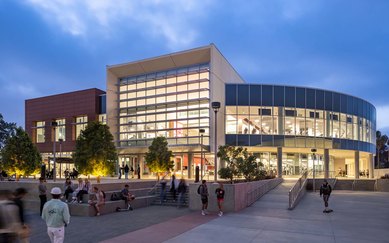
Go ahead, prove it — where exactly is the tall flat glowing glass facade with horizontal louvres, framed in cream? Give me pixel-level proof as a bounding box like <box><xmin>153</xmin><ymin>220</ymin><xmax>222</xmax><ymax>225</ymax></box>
<box><xmin>118</xmin><ymin>64</ymin><xmax>210</xmax><ymax>147</ymax></box>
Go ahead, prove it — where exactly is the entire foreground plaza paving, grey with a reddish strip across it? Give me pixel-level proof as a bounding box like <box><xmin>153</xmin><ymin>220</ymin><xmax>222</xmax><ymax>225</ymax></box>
<box><xmin>29</xmin><ymin>182</ymin><xmax>389</xmax><ymax>243</ymax></box>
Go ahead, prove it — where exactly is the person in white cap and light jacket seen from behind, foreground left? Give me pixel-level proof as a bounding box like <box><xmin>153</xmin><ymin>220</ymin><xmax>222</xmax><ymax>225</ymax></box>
<box><xmin>42</xmin><ymin>187</ymin><xmax>70</xmax><ymax>243</ymax></box>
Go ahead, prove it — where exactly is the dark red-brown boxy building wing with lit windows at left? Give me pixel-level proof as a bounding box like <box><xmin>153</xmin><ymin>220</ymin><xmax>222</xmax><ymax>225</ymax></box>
<box><xmin>25</xmin><ymin>89</ymin><xmax>106</xmax><ymax>178</ymax></box>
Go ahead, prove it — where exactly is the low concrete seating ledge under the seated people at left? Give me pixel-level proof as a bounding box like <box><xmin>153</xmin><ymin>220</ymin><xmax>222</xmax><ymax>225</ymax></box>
<box><xmin>68</xmin><ymin>195</ymin><xmax>156</xmax><ymax>216</ymax></box>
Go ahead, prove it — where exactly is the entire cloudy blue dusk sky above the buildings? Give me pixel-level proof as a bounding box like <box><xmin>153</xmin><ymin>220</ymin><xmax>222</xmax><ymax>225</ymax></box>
<box><xmin>0</xmin><ymin>0</ymin><xmax>389</xmax><ymax>134</ymax></box>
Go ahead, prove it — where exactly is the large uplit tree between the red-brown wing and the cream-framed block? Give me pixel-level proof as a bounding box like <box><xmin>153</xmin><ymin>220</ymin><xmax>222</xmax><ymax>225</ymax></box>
<box><xmin>73</xmin><ymin>121</ymin><xmax>117</xmax><ymax>178</ymax></box>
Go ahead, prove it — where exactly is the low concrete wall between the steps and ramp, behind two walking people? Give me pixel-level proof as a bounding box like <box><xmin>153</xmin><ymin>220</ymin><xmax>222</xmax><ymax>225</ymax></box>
<box><xmin>189</xmin><ymin>178</ymin><xmax>282</xmax><ymax>212</ymax></box>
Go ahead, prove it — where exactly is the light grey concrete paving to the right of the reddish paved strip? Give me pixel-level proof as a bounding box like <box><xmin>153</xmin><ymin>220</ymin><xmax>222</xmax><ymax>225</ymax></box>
<box><xmin>166</xmin><ymin>189</ymin><xmax>389</xmax><ymax>243</ymax></box>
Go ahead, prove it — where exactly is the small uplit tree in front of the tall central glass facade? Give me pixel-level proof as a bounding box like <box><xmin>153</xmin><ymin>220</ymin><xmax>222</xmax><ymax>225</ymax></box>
<box><xmin>146</xmin><ymin>137</ymin><xmax>174</xmax><ymax>180</ymax></box>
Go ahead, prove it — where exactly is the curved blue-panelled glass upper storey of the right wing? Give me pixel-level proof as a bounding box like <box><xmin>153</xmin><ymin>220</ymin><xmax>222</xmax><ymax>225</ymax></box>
<box><xmin>225</xmin><ymin>84</ymin><xmax>376</xmax><ymax>153</ymax></box>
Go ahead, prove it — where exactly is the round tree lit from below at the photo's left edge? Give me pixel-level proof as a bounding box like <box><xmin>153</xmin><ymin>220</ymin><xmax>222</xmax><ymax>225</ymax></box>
<box><xmin>1</xmin><ymin>127</ymin><xmax>42</xmax><ymax>180</ymax></box>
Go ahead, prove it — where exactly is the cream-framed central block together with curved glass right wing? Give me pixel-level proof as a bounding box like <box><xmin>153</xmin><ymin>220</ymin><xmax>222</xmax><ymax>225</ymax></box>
<box><xmin>106</xmin><ymin>44</ymin><xmax>376</xmax><ymax>178</ymax></box>
